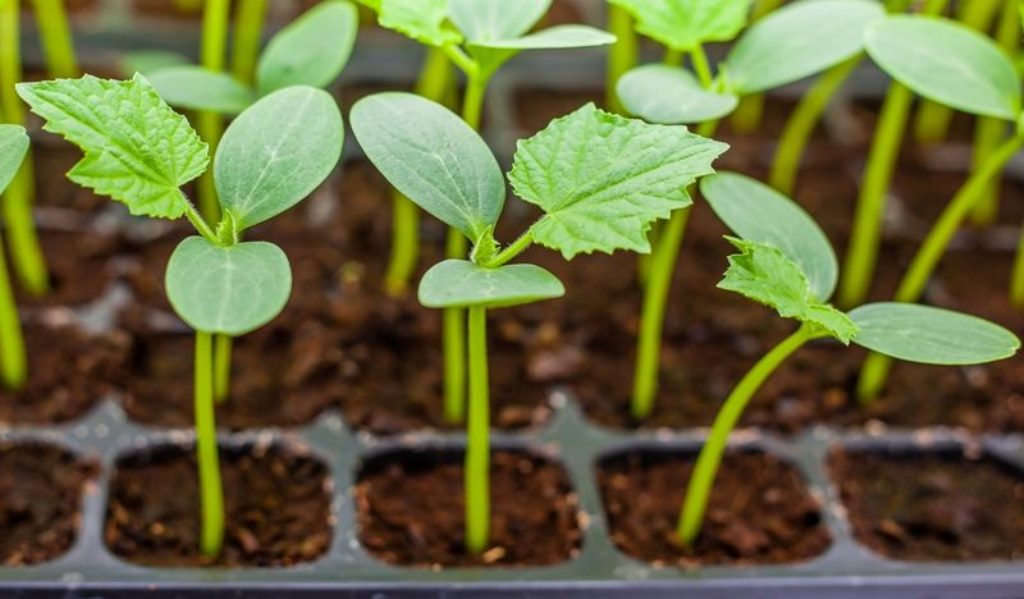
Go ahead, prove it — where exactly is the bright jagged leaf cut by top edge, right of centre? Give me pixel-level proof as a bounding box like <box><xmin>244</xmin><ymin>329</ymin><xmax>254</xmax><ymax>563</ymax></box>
<box><xmin>609</xmin><ymin>0</ymin><xmax>753</xmax><ymax>52</ymax></box>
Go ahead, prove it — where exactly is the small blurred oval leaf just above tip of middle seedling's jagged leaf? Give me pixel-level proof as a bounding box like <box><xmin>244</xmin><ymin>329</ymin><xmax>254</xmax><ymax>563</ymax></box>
<box><xmin>615</xmin><ymin>65</ymin><xmax>739</xmax><ymax>125</ymax></box>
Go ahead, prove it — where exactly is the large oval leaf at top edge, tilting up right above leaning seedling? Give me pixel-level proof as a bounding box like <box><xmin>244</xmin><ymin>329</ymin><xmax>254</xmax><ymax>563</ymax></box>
<box><xmin>725</xmin><ymin>0</ymin><xmax>886</xmax><ymax>95</ymax></box>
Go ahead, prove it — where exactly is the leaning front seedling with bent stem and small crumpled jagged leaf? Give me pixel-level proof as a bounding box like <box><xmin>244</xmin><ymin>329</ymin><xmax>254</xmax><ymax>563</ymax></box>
<box><xmin>678</xmin><ymin>173</ymin><xmax>1020</xmax><ymax>545</ymax></box>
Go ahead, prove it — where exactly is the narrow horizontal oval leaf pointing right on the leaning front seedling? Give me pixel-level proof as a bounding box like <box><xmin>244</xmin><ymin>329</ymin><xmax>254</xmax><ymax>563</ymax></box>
<box><xmin>850</xmin><ymin>303</ymin><xmax>1020</xmax><ymax>365</ymax></box>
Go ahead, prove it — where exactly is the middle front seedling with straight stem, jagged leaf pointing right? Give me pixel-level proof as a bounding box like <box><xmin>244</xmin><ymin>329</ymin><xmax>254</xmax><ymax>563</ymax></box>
<box><xmin>351</xmin><ymin>93</ymin><xmax>727</xmax><ymax>553</ymax></box>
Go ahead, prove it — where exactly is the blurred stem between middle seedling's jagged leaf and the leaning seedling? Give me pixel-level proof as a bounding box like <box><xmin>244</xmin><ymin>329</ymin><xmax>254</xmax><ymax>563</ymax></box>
<box><xmin>630</xmin><ymin>208</ymin><xmax>690</xmax><ymax>420</ymax></box>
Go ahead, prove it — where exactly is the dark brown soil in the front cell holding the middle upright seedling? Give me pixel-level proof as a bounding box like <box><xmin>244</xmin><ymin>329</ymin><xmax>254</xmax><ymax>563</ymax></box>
<box><xmin>355</xmin><ymin>452</ymin><xmax>583</xmax><ymax>567</ymax></box>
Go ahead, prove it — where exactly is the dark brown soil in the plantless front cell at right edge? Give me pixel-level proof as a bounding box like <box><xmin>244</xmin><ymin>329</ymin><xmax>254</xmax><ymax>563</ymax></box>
<box><xmin>830</xmin><ymin>452</ymin><xmax>1024</xmax><ymax>561</ymax></box>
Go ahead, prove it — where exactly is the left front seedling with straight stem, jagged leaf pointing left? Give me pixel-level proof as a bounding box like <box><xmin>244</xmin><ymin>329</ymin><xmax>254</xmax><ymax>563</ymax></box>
<box><xmin>17</xmin><ymin>75</ymin><xmax>344</xmax><ymax>556</ymax></box>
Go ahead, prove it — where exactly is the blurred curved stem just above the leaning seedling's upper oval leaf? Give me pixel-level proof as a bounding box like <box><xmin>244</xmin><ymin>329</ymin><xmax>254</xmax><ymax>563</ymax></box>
<box><xmin>769</xmin><ymin>54</ymin><xmax>863</xmax><ymax>196</ymax></box>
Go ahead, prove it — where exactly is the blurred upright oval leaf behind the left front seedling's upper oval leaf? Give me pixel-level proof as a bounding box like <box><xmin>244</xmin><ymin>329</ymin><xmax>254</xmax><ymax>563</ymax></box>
<box><xmin>256</xmin><ymin>0</ymin><xmax>359</xmax><ymax>95</ymax></box>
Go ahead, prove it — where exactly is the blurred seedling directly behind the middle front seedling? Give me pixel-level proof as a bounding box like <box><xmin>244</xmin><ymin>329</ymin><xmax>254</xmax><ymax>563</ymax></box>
<box><xmin>360</xmin><ymin>0</ymin><xmax>615</xmax><ymax>422</ymax></box>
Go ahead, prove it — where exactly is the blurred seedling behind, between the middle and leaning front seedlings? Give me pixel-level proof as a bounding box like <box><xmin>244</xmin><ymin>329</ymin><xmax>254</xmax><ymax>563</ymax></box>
<box><xmin>618</xmin><ymin>0</ymin><xmax>884</xmax><ymax>419</ymax></box>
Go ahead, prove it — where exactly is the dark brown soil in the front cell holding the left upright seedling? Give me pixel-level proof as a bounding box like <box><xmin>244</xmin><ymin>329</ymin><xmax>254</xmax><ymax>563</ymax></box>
<box><xmin>104</xmin><ymin>446</ymin><xmax>333</xmax><ymax>567</ymax></box>
